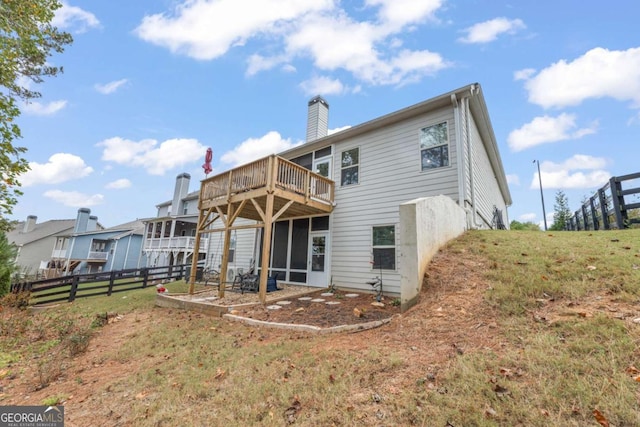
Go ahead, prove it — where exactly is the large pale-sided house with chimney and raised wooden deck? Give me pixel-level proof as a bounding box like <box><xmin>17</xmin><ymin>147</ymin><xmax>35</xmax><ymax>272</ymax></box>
<box><xmin>182</xmin><ymin>84</ymin><xmax>511</xmax><ymax>304</ymax></box>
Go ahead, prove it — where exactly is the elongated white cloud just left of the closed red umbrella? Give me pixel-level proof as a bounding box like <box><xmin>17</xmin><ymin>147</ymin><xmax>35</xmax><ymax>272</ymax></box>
<box><xmin>96</xmin><ymin>137</ymin><xmax>207</xmax><ymax>175</ymax></box>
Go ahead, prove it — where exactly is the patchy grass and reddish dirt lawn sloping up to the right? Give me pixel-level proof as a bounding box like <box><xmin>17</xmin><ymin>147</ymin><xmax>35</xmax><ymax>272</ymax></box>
<box><xmin>0</xmin><ymin>230</ymin><xmax>640</xmax><ymax>427</ymax></box>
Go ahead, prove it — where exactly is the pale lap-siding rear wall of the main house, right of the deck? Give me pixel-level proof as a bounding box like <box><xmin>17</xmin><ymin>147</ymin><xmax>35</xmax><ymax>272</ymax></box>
<box><xmin>331</xmin><ymin>108</ymin><xmax>458</xmax><ymax>294</ymax></box>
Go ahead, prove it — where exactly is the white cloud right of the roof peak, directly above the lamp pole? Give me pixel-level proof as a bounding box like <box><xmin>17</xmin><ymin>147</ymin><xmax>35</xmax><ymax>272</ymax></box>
<box><xmin>507</xmin><ymin>113</ymin><xmax>598</xmax><ymax>151</ymax></box>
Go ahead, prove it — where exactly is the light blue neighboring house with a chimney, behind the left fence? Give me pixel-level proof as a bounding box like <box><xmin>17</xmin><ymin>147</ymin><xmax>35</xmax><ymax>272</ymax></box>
<box><xmin>49</xmin><ymin>209</ymin><xmax>146</xmax><ymax>277</ymax></box>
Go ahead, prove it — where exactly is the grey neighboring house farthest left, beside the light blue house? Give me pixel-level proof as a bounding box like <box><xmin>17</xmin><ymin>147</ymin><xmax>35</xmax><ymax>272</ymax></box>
<box><xmin>7</xmin><ymin>215</ymin><xmax>76</xmax><ymax>276</ymax></box>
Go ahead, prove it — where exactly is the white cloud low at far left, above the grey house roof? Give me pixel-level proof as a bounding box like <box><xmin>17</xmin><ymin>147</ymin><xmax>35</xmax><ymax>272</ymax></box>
<box><xmin>20</xmin><ymin>153</ymin><xmax>93</xmax><ymax>187</ymax></box>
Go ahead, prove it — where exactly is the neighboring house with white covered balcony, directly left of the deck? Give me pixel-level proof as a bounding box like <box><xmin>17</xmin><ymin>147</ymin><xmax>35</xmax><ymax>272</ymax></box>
<box><xmin>142</xmin><ymin>173</ymin><xmax>255</xmax><ymax>281</ymax></box>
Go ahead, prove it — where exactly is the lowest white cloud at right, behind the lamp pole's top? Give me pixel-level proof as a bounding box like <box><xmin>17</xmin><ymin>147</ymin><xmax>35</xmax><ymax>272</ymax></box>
<box><xmin>529</xmin><ymin>154</ymin><xmax>611</xmax><ymax>189</ymax></box>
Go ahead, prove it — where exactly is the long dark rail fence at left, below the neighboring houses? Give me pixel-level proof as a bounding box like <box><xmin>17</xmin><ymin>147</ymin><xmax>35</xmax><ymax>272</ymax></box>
<box><xmin>11</xmin><ymin>264</ymin><xmax>198</xmax><ymax>305</ymax></box>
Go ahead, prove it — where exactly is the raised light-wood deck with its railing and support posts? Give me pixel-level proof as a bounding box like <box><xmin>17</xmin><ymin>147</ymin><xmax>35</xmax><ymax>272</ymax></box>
<box><xmin>189</xmin><ymin>155</ymin><xmax>335</xmax><ymax>303</ymax></box>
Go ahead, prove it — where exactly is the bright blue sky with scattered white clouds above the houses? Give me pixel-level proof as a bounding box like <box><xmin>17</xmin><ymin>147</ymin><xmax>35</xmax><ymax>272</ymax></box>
<box><xmin>8</xmin><ymin>0</ymin><xmax>640</xmax><ymax>231</ymax></box>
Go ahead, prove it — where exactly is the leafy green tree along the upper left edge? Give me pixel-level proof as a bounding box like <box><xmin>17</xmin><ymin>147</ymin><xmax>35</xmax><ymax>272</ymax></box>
<box><xmin>0</xmin><ymin>0</ymin><xmax>73</xmax><ymax>231</ymax></box>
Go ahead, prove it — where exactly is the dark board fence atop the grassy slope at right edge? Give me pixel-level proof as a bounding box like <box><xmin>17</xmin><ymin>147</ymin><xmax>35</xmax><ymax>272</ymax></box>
<box><xmin>566</xmin><ymin>172</ymin><xmax>640</xmax><ymax>230</ymax></box>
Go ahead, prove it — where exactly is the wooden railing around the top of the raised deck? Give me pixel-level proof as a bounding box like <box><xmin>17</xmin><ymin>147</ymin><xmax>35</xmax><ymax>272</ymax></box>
<box><xmin>200</xmin><ymin>155</ymin><xmax>335</xmax><ymax>204</ymax></box>
